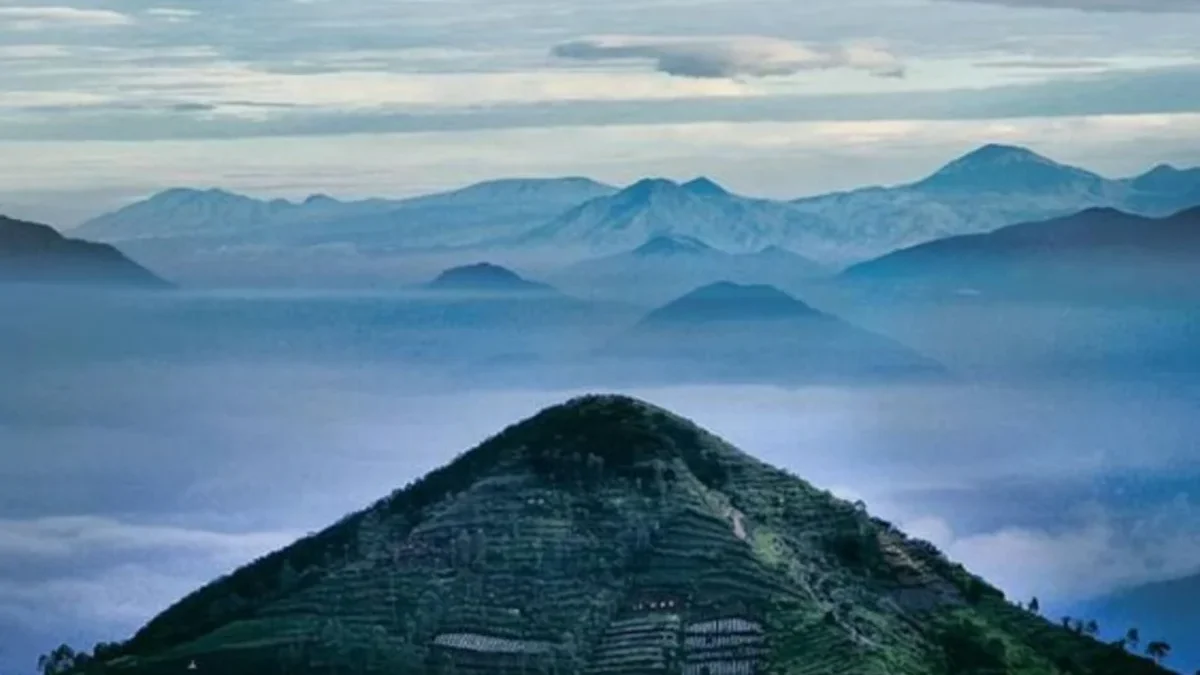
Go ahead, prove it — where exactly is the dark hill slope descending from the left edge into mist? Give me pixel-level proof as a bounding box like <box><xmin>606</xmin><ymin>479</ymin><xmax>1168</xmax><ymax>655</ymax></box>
<box><xmin>0</xmin><ymin>216</ymin><xmax>169</xmax><ymax>287</ymax></box>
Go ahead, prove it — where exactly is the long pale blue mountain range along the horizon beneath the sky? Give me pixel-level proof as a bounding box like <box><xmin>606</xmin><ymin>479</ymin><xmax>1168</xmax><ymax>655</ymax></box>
<box><xmin>77</xmin><ymin>144</ymin><xmax>1200</xmax><ymax>274</ymax></box>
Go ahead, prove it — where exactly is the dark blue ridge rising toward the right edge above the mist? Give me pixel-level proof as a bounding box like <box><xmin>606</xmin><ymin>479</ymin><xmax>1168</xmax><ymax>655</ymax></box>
<box><xmin>842</xmin><ymin>208</ymin><xmax>1200</xmax><ymax>298</ymax></box>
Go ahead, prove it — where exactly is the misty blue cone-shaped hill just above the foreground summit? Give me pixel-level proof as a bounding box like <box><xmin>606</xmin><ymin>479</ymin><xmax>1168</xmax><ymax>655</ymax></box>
<box><xmin>599</xmin><ymin>282</ymin><xmax>944</xmax><ymax>383</ymax></box>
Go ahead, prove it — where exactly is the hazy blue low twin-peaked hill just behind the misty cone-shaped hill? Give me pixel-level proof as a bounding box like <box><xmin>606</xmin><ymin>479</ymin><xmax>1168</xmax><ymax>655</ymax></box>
<box><xmin>550</xmin><ymin>234</ymin><xmax>830</xmax><ymax>304</ymax></box>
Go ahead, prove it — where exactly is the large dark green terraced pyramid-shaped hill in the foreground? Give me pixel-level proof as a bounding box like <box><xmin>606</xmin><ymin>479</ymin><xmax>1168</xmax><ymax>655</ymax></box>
<box><xmin>72</xmin><ymin>396</ymin><xmax>1165</xmax><ymax>675</ymax></box>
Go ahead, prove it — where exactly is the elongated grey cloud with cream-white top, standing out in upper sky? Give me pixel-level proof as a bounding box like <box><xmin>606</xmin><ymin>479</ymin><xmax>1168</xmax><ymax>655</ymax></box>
<box><xmin>552</xmin><ymin>35</ymin><xmax>905</xmax><ymax>78</ymax></box>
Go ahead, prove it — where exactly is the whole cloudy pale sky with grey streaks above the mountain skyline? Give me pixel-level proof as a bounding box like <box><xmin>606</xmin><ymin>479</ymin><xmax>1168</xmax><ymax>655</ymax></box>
<box><xmin>0</xmin><ymin>0</ymin><xmax>1200</xmax><ymax>221</ymax></box>
